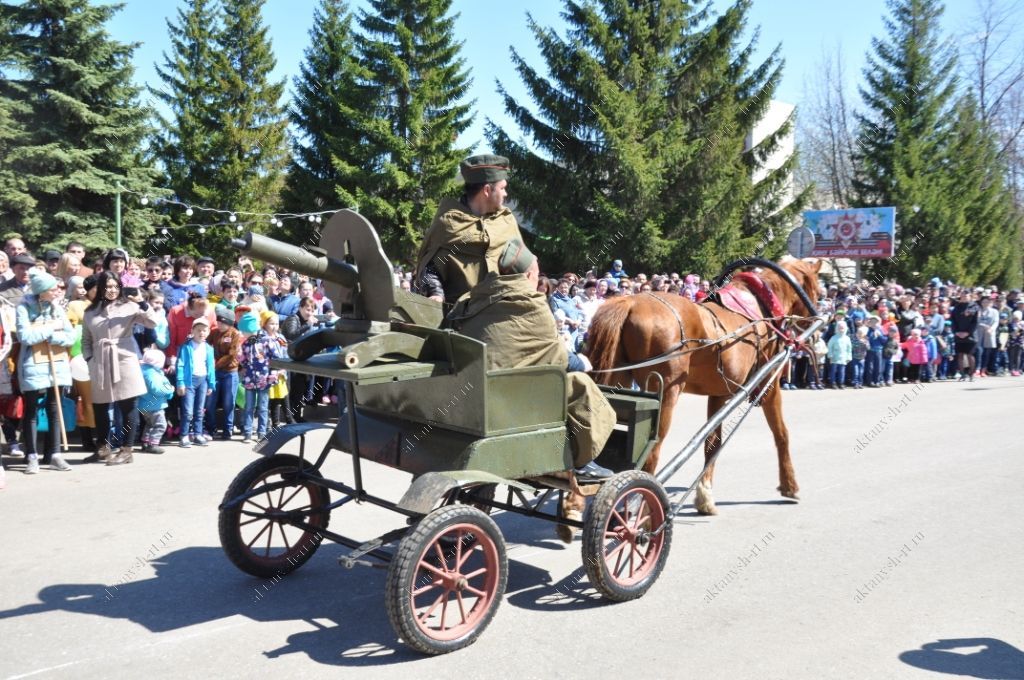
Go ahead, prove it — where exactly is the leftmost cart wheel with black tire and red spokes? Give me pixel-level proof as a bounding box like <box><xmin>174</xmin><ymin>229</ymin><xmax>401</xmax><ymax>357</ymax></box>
<box><xmin>218</xmin><ymin>454</ymin><xmax>331</xmax><ymax>578</ymax></box>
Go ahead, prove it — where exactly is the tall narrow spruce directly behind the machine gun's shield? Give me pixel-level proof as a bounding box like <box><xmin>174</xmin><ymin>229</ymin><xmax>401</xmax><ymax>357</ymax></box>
<box><xmin>353</xmin><ymin>0</ymin><xmax>472</xmax><ymax>260</ymax></box>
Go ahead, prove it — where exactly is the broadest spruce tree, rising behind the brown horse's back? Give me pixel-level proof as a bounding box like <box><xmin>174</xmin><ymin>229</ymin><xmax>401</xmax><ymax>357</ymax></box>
<box><xmin>487</xmin><ymin>0</ymin><xmax>799</xmax><ymax>273</ymax></box>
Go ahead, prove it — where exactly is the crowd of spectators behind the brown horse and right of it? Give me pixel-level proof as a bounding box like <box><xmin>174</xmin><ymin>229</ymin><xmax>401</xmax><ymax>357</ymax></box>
<box><xmin>538</xmin><ymin>260</ymin><xmax>1024</xmax><ymax>390</ymax></box>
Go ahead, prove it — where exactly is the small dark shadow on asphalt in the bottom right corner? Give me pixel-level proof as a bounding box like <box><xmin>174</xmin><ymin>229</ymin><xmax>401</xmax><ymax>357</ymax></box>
<box><xmin>899</xmin><ymin>638</ymin><xmax>1024</xmax><ymax>680</ymax></box>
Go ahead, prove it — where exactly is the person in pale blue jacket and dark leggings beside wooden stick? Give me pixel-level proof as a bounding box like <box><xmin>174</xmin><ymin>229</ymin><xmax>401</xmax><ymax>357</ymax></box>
<box><xmin>16</xmin><ymin>271</ymin><xmax>75</xmax><ymax>474</ymax></box>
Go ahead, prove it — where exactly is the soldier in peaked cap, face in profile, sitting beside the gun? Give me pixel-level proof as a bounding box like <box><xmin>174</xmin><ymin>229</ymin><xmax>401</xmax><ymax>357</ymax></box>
<box><xmin>415</xmin><ymin>155</ymin><xmax>522</xmax><ymax>304</ymax></box>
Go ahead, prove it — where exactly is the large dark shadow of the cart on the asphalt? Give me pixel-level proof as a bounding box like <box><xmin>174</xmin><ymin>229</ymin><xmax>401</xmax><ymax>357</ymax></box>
<box><xmin>0</xmin><ymin>522</ymin><xmax>565</xmax><ymax>667</ymax></box>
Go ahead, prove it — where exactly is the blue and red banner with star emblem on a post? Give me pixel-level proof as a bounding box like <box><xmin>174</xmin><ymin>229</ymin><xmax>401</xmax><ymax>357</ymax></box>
<box><xmin>804</xmin><ymin>208</ymin><xmax>896</xmax><ymax>259</ymax></box>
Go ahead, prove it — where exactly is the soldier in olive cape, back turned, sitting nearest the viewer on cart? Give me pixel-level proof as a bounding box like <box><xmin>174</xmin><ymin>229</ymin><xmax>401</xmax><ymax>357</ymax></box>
<box><xmin>445</xmin><ymin>239</ymin><xmax>615</xmax><ymax>481</ymax></box>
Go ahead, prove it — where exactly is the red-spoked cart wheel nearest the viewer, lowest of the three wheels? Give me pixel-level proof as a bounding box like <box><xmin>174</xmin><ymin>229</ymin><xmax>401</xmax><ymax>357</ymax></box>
<box><xmin>385</xmin><ymin>505</ymin><xmax>508</xmax><ymax>654</ymax></box>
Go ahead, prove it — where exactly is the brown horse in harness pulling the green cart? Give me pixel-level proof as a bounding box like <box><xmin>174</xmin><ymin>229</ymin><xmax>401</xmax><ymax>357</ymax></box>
<box><xmin>581</xmin><ymin>258</ymin><xmax>821</xmax><ymax>515</ymax></box>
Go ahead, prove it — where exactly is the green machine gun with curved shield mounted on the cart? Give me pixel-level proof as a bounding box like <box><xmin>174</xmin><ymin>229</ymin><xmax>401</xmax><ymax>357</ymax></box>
<box><xmin>231</xmin><ymin>210</ymin><xmax>442</xmax><ymax>369</ymax></box>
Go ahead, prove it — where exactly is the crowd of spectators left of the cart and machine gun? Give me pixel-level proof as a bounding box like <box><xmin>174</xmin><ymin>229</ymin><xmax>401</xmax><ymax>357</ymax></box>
<box><xmin>0</xmin><ymin>238</ymin><xmax>338</xmax><ymax>483</ymax></box>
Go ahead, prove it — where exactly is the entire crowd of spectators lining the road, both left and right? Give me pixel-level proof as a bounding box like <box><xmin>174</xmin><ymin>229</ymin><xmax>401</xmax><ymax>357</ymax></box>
<box><xmin>0</xmin><ymin>238</ymin><xmax>1024</xmax><ymax>483</ymax></box>
